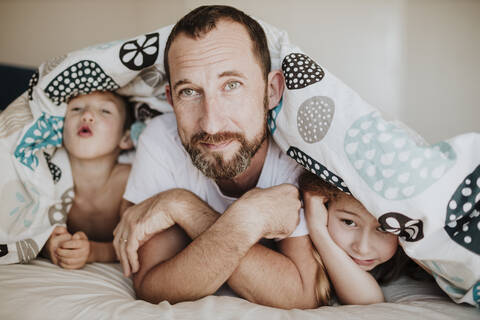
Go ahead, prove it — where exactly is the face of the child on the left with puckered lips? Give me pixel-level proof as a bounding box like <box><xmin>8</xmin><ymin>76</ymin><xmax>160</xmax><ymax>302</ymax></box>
<box><xmin>63</xmin><ymin>92</ymin><xmax>126</xmax><ymax>159</ymax></box>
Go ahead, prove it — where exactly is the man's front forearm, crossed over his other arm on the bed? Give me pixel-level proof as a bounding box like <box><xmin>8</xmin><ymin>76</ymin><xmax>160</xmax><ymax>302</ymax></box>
<box><xmin>137</xmin><ymin>212</ymin><xmax>255</xmax><ymax>303</ymax></box>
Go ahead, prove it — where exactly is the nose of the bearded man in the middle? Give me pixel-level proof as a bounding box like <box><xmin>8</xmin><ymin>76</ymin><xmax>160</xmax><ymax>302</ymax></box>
<box><xmin>199</xmin><ymin>95</ymin><xmax>227</xmax><ymax>134</ymax></box>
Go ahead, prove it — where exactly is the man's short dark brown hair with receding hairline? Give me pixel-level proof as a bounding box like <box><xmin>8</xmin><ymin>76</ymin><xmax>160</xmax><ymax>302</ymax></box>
<box><xmin>163</xmin><ymin>5</ymin><xmax>271</xmax><ymax>82</ymax></box>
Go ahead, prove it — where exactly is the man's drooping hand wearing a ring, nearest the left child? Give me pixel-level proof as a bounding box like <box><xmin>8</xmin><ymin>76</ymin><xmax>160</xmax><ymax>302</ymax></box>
<box><xmin>113</xmin><ymin>192</ymin><xmax>175</xmax><ymax>277</ymax></box>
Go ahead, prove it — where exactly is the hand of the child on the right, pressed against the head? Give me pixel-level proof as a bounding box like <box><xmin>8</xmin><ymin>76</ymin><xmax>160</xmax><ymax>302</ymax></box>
<box><xmin>303</xmin><ymin>191</ymin><xmax>328</xmax><ymax>232</ymax></box>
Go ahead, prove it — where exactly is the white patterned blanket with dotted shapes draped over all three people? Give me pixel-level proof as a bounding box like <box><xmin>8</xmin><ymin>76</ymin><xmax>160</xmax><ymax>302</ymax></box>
<box><xmin>0</xmin><ymin>18</ymin><xmax>480</xmax><ymax>306</ymax></box>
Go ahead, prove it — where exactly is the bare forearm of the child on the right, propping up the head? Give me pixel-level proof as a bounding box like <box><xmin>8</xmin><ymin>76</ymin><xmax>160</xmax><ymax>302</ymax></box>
<box><xmin>310</xmin><ymin>229</ymin><xmax>385</xmax><ymax>304</ymax></box>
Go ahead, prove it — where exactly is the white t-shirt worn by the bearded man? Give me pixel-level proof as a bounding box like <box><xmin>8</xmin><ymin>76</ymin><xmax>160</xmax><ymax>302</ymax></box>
<box><xmin>124</xmin><ymin>113</ymin><xmax>308</xmax><ymax>237</ymax></box>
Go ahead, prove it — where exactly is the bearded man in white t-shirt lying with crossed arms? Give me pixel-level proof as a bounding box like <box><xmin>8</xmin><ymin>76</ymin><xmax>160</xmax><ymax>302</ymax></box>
<box><xmin>114</xmin><ymin>6</ymin><xmax>318</xmax><ymax>308</ymax></box>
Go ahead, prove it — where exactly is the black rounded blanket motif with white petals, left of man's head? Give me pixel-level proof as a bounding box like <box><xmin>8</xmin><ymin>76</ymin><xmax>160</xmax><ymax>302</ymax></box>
<box><xmin>119</xmin><ymin>33</ymin><xmax>160</xmax><ymax>70</ymax></box>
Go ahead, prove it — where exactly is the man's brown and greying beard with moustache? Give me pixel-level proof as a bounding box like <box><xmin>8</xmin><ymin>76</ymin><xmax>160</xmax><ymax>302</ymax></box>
<box><xmin>182</xmin><ymin>94</ymin><xmax>268</xmax><ymax>180</ymax></box>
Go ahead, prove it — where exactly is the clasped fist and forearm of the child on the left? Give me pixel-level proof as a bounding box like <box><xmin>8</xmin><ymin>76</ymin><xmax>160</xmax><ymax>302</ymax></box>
<box><xmin>56</xmin><ymin>231</ymin><xmax>117</xmax><ymax>269</ymax></box>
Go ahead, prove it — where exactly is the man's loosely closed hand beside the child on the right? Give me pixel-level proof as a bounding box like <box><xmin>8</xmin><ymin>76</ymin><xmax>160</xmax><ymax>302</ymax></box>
<box><xmin>228</xmin><ymin>184</ymin><xmax>301</xmax><ymax>239</ymax></box>
